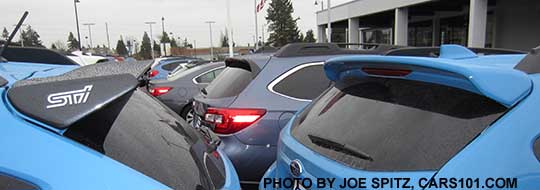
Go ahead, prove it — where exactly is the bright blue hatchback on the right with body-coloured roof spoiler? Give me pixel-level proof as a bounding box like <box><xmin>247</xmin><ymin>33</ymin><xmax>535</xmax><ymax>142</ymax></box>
<box><xmin>259</xmin><ymin>45</ymin><xmax>540</xmax><ymax>189</ymax></box>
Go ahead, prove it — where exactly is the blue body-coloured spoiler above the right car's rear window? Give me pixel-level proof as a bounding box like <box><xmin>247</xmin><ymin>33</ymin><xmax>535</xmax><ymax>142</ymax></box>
<box><xmin>324</xmin><ymin>54</ymin><xmax>532</xmax><ymax>107</ymax></box>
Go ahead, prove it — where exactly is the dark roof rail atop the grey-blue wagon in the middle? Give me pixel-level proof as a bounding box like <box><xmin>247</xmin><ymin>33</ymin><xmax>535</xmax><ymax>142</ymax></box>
<box><xmin>274</xmin><ymin>43</ymin><xmax>393</xmax><ymax>57</ymax></box>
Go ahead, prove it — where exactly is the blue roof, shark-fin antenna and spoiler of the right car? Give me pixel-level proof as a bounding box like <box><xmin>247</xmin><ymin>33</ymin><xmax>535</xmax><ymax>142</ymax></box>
<box><xmin>325</xmin><ymin>46</ymin><xmax>532</xmax><ymax>107</ymax></box>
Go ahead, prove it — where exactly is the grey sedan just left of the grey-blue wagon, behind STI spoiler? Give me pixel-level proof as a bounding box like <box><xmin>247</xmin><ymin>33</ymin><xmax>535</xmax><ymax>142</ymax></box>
<box><xmin>149</xmin><ymin>62</ymin><xmax>225</xmax><ymax>124</ymax></box>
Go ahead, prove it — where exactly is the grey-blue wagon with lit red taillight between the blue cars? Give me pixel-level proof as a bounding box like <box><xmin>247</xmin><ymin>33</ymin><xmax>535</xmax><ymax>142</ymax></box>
<box><xmin>194</xmin><ymin>44</ymin><xmax>394</xmax><ymax>185</ymax></box>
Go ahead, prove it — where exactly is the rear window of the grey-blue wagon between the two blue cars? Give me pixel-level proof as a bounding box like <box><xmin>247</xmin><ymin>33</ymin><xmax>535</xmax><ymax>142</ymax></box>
<box><xmin>205</xmin><ymin>67</ymin><xmax>253</xmax><ymax>98</ymax></box>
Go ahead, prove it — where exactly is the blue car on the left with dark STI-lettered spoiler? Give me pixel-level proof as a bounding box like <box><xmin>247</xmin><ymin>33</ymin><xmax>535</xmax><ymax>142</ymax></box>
<box><xmin>0</xmin><ymin>58</ymin><xmax>240</xmax><ymax>190</ymax></box>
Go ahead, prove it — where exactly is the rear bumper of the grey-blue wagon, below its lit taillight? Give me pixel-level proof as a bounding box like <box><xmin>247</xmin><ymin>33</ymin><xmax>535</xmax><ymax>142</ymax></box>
<box><xmin>220</xmin><ymin>136</ymin><xmax>276</xmax><ymax>183</ymax></box>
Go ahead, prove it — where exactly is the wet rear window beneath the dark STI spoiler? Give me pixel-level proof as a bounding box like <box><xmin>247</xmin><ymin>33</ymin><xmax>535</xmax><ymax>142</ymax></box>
<box><xmin>64</xmin><ymin>90</ymin><xmax>225</xmax><ymax>189</ymax></box>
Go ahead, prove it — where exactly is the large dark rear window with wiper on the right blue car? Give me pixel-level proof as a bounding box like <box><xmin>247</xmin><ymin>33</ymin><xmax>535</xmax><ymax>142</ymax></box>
<box><xmin>292</xmin><ymin>78</ymin><xmax>507</xmax><ymax>171</ymax></box>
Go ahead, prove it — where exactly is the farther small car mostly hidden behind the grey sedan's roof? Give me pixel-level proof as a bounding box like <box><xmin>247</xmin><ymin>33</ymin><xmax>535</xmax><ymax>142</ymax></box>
<box><xmin>151</xmin><ymin>57</ymin><xmax>201</xmax><ymax>80</ymax></box>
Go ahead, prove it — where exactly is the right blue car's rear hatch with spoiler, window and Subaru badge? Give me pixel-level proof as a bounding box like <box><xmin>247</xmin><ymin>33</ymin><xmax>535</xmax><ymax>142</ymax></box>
<box><xmin>276</xmin><ymin>56</ymin><xmax>532</xmax><ymax>187</ymax></box>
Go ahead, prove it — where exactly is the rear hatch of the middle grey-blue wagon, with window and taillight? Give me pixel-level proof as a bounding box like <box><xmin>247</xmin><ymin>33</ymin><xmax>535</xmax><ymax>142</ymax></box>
<box><xmin>193</xmin><ymin>58</ymin><xmax>267</xmax><ymax>133</ymax></box>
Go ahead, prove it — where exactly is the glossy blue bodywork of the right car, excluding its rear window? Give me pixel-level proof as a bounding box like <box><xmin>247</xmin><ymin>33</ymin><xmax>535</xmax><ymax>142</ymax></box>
<box><xmin>259</xmin><ymin>50</ymin><xmax>540</xmax><ymax>189</ymax></box>
